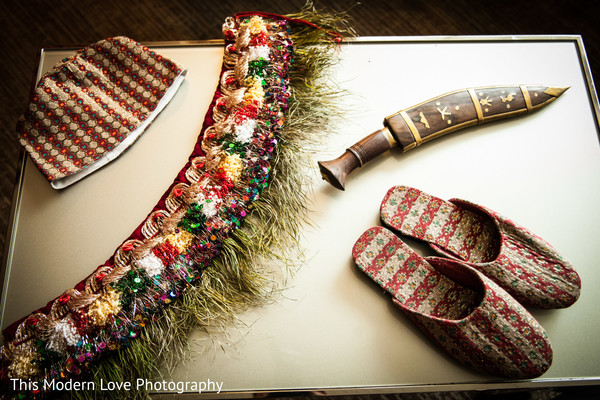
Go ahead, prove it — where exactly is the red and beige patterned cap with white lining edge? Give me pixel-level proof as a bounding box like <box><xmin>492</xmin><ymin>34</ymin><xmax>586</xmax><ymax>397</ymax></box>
<box><xmin>17</xmin><ymin>36</ymin><xmax>186</xmax><ymax>189</ymax></box>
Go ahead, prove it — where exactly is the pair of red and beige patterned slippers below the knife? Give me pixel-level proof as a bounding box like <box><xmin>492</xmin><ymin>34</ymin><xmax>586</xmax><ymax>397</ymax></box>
<box><xmin>352</xmin><ymin>186</ymin><xmax>581</xmax><ymax>379</ymax></box>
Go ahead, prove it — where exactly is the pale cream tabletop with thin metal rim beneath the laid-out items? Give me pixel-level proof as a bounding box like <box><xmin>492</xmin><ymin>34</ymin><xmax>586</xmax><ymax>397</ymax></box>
<box><xmin>2</xmin><ymin>36</ymin><xmax>600</xmax><ymax>397</ymax></box>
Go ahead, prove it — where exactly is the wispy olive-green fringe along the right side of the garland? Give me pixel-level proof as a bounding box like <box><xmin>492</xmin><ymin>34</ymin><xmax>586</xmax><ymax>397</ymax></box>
<box><xmin>61</xmin><ymin>2</ymin><xmax>354</xmax><ymax>400</ymax></box>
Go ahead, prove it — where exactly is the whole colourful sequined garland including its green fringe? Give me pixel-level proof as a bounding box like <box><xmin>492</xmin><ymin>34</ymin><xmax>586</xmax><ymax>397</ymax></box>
<box><xmin>0</xmin><ymin>5</ymin><xmax>352</xmax><ymax>398</ymax></box>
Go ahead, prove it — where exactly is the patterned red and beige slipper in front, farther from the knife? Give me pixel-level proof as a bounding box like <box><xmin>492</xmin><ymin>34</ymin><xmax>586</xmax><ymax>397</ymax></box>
<box><xmin>352</xmin><ymin>227</ymin><xmax>552</xmax><ymax>379</ymax></box>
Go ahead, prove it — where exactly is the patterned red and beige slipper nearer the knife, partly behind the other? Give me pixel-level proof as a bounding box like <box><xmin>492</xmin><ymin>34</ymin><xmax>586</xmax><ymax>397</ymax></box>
<box><xmin>381</xmin><ymin>186</ymin><xmax>581</xmax><ymax>308</ymax></box>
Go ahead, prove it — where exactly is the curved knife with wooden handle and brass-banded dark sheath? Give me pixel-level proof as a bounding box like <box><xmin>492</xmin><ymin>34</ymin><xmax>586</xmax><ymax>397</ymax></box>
<box><xmin>318</xmin><ymin>85</ymin><xmax>568</xmax><ymax>190</ymax></box>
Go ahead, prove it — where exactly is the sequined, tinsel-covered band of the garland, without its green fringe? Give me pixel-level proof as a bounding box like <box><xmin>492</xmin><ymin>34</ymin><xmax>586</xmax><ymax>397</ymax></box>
<box><xmin>1</xmin><ymin>15</ymin><xmax>293</xmax><ymax>390</ymax></box>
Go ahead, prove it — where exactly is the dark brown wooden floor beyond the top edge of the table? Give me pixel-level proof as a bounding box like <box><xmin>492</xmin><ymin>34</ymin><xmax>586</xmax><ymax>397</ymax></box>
<box><xmin>0</xmin><ymin>0</ymin><xmax>600</xmax><ymax>398</ymax></box>
